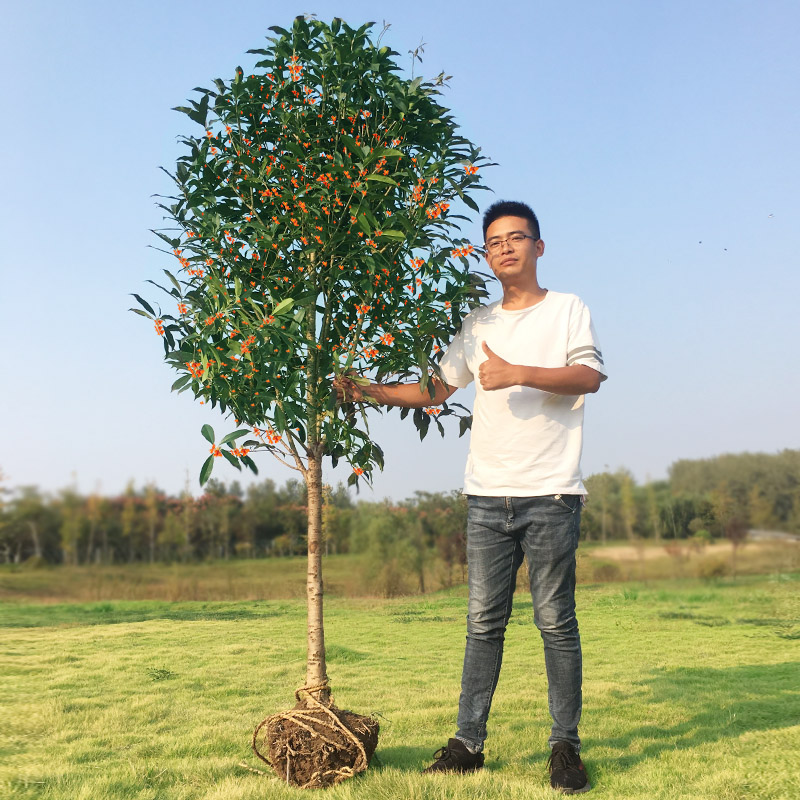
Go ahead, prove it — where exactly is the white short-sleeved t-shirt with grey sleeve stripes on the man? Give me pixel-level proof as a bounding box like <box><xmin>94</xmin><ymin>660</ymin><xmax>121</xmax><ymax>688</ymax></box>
<box><xmin>439</xmin><ymin>291</ymin><xmax>607</xmax><ymax>497</ymax></box>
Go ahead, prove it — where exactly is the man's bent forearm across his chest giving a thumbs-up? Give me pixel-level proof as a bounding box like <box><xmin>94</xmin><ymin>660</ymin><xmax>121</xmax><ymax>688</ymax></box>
<box><xmin>478</xmin><ymin>342</ymin><xmax>602</xmax><ymax>394</ymax></box>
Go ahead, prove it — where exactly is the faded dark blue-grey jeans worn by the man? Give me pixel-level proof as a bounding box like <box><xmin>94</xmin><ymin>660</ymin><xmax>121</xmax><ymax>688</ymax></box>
<box><xmin>456</xmin><ymin>495</ymin><xmax>582</xmax><ymax>751</ymax></box>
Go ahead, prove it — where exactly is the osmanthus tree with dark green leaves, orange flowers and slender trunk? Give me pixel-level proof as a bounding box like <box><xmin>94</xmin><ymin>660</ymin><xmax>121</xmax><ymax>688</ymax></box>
<box><xmin>136</xmin><ymin>17</ymin><xmax>488</xmax><ymax>785</ymax></box>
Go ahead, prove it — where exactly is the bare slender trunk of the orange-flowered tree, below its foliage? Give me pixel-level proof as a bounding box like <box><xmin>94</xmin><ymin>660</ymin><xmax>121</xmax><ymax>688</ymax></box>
<box><xmin>306</xmin><ymin>453</ymin><xmax>330</xmax><ymax>703</ymax></box>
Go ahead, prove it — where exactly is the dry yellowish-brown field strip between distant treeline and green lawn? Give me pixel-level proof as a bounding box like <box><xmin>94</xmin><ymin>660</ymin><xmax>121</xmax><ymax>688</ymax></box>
<box><xmin>0</xmin><ymin>541</ymin><xmax>800</xmax><ymax>603</ymax></box>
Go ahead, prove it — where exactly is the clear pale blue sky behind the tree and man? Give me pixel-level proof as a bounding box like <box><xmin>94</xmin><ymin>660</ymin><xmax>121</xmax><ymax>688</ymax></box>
<box><xmin>0</xmin><ymin>0</ymin><xmax>800</xmax><ymax>500</ymax></box>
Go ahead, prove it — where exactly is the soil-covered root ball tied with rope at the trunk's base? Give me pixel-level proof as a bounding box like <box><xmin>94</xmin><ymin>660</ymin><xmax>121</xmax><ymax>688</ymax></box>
<box><xmin>253</xmin><ymin>689</ymin><xmax>379</xmax><ymax>789</ymax></box>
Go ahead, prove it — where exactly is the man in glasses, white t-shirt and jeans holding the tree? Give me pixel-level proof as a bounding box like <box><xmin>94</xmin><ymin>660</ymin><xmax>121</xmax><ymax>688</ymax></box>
<box><xmin>340</xmin><ymin>202</ymin><xmax>606</xmax><ymax>794</ymax></box>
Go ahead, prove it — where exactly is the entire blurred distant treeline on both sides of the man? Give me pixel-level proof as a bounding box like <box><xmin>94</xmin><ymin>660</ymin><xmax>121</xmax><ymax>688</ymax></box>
<box><xmin>0</xmin><ymin>450</ymin><xmax>800</xmax><ymax>564</ymax></box>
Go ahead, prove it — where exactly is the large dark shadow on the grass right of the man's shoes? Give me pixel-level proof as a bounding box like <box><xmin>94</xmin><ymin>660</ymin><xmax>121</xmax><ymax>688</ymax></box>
<box><xmin>587</xmin><ymin>662</ymin><xmax>800</xmax><ymax>769</ymax></box>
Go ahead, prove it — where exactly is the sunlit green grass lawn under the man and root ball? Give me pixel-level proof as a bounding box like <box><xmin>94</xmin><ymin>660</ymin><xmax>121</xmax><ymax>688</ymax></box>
<box><xmin>0</xmin><ymin>573</ymin><xmax>800</xmax><ymax>800</ymax></box>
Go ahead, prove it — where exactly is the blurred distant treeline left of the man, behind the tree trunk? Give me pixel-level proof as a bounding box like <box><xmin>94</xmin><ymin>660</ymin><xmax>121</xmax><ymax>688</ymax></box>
<box><xmin>0</xmin><ymin>472</ymin><xmax>466</xmax><ymax>591</ymax></box>
